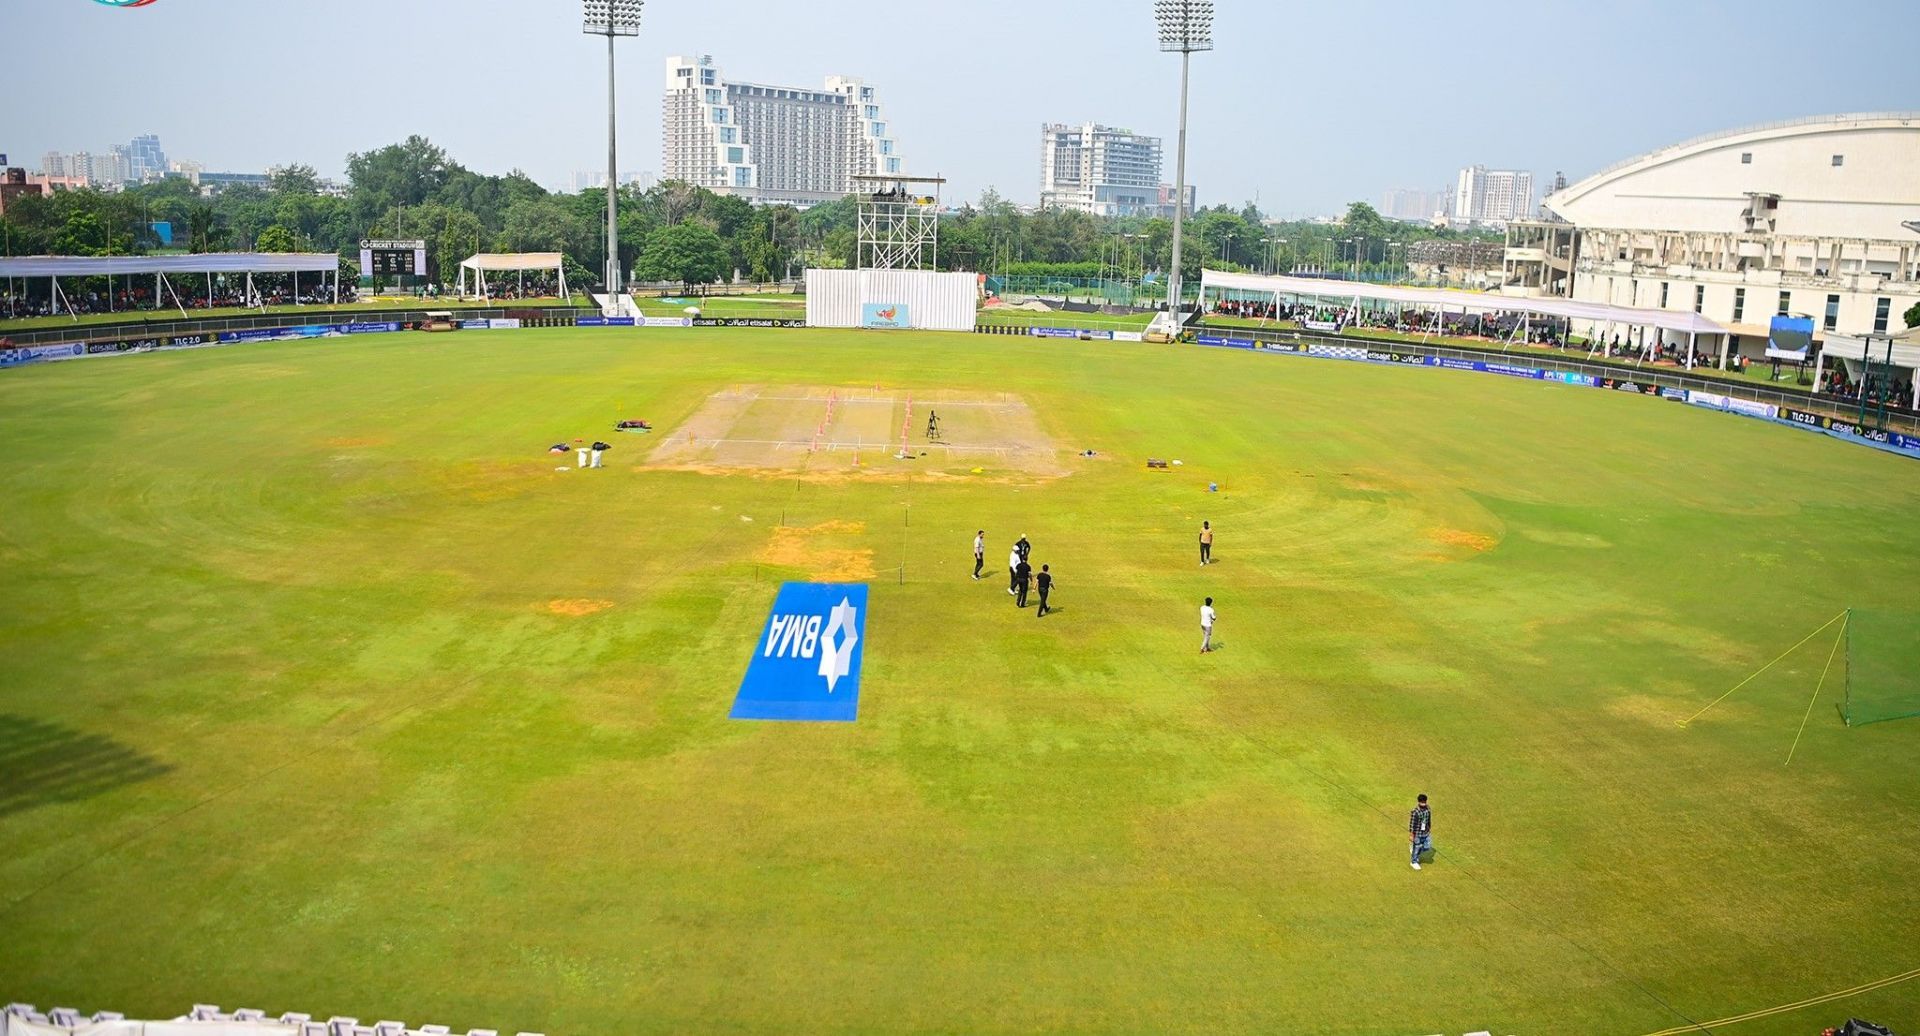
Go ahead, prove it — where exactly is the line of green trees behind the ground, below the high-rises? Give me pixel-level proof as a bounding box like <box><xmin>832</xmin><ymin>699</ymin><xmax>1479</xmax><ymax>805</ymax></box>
<box><xmin>0</xmin><ymin>136</ymin><xmax>1497</xmax><ymax>286</ymax></box>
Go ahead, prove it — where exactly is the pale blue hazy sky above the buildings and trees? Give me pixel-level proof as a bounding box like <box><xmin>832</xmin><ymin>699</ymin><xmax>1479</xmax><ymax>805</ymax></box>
<box><xmin>0</xmin><ymin>0</ymin><xmax>1920</xmax><ymax>215</ymax></box>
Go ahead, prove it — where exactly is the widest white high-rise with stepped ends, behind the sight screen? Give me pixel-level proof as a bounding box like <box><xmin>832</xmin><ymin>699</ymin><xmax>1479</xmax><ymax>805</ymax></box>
<box><xmin>660</xmin><ymin>56</ymin><xmax>902</xmax><ymax>207</ymax></box>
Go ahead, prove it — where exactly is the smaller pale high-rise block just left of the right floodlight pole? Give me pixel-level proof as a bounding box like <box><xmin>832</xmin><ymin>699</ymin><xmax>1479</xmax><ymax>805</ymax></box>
<box><xmin>1041</xmin><ymin>123</ymin><xmax>1160</xmax><ymax>215</ymax></box>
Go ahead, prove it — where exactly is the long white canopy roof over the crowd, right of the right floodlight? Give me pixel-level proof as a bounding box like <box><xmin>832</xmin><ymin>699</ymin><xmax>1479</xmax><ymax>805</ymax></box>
<box><xmin>1200</xmin><ymin>271</ymin><xmax>1728</xmax><ymax>366</ymax></box>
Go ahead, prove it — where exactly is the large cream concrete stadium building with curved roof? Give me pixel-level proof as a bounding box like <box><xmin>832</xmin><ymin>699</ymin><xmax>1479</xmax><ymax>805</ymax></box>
<box><xmin>1501</xmin><ymin>111</ymin><xmax>1920</xmax><ymax>366</ymax></box>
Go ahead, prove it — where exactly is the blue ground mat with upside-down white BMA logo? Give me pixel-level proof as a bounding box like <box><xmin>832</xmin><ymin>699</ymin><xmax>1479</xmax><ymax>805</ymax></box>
<box><xmin>730</xmin><ymin>583</ymin><xmax>866</xmax><ymax>721</ymax></box>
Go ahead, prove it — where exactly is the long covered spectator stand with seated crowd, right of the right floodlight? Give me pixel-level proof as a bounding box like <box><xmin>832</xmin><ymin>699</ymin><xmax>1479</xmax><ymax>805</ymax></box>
<box><xmin>1200</xmin><ymin>269</ymin><xmax>1732</xmax><ymax>370</ymax></box>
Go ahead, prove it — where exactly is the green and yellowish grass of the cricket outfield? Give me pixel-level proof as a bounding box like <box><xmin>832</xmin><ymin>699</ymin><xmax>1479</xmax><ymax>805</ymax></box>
<box><xmin>0</xmin><ymin>330</ymin><xmax>1920</xmax><ymax>1036</ymax></box>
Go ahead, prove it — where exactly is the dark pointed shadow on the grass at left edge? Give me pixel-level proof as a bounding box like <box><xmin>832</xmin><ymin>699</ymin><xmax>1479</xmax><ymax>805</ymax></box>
<box><xmin>0</xmin><ymin>712</ymin><xmax>173</xmax><ymax>817</ymax></box>
